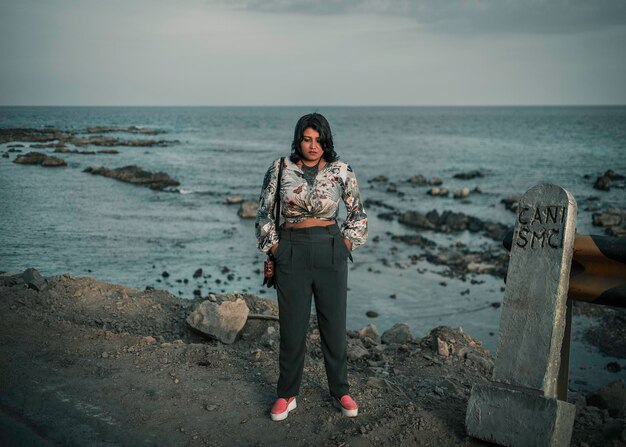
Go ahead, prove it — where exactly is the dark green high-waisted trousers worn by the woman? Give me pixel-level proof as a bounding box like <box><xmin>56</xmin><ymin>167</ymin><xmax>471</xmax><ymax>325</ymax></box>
<box><xmin>274</xmin><ymin>224</ymin><xmax>352</xmax><ymax>398</ymax></box>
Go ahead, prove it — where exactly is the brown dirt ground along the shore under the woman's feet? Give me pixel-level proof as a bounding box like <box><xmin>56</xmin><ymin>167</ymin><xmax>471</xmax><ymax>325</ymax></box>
<box><xmin>0</xmin><ymin>274</ymin><xmax>626</xmax><ymax>447</ymax></box>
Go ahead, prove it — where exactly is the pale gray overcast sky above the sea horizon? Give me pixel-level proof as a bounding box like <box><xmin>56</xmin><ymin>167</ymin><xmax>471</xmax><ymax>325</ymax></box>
<box><xmin>0</xmin><ymin>0</ymin><xmax>626</xmax><ymax>106</ymax></box>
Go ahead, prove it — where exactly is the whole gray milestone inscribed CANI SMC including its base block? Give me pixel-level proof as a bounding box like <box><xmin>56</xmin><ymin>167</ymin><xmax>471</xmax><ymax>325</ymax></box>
<box><xmin>465</xmin><ymin>185</ymin><xmax>577</xmax><ymax>447</ymax></box>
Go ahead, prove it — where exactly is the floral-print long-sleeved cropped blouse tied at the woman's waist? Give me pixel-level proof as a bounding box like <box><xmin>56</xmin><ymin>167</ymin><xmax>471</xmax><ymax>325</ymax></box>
<box><xmin>255</xmin><ymin>157</ymin><xmax>367</xmax><ymax>253</ymax></box>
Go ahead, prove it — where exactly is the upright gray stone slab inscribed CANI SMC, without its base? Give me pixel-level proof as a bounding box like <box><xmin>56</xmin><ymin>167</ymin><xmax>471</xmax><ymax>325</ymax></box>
<box><xmin>493</xmin><ymin>185</ymin><xmax>577</xmax><ymax>397</ymax></box>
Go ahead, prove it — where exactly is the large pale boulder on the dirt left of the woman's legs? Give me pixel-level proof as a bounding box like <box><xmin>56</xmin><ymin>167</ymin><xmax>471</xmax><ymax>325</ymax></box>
<box><xmin>187</xmin><ymin>298</ymin><xmax>250</xmax><ymax>344</ymax></box>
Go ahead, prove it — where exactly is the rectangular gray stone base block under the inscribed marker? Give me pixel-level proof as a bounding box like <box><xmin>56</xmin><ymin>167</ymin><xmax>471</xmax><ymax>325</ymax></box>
<box><xmin>465</xmin><ymin>384</ymin><xmax>576</xmax><ymax>447</ymax></box>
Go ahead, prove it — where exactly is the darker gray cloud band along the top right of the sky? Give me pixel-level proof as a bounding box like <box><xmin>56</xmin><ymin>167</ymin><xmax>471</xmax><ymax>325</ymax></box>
<box><xmin>221</xmin><ymin>0</ymin><xmax>626</xmax><ymax>34</ymax></box>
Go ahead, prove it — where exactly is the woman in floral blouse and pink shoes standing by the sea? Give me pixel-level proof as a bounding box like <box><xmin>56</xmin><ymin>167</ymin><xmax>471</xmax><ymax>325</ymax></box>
<box><xmin>256</xmin><ymin>113</ymin><xmax>367</xmax><ymax>421</ymax></box>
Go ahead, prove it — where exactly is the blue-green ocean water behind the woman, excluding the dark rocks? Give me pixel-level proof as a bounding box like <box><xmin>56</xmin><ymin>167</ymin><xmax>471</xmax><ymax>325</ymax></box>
<box><xmin>0</xmin><ymin>107</ymin><xmax>626</xmax><ymax>387</ymax></box>
